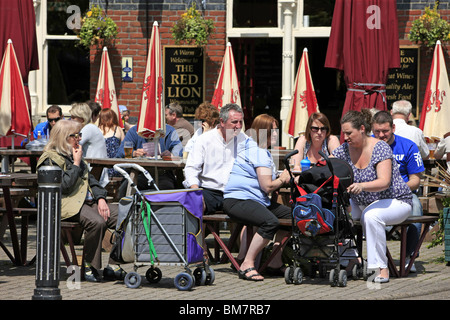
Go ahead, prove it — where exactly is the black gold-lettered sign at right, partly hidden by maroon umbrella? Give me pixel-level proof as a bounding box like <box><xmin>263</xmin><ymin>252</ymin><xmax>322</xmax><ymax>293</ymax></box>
<box><xmin>386</xmin><ymin>46</ymin><xmax>420</xmax><ymax>120</ymax></box>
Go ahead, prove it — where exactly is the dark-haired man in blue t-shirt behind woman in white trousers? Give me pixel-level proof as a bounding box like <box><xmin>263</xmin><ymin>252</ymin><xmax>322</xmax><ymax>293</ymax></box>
<box><xmin>372</xmin><ymin>111</ymin><xmax>425</xmax><ymax>272</ymax></box>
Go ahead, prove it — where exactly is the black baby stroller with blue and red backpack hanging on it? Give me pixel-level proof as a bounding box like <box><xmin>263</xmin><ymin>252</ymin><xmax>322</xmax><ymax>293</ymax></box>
<box><xmin>284</xmin><ymin>150</ymin><xmax>366</xmax><ymax>287</ymax></box>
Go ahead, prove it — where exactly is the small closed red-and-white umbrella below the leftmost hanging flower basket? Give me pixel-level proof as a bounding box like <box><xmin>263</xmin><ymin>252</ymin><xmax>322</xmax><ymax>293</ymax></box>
<box><xmin>95</xmin><ymin>47</ymin><xmax>123</xmax><ymax>128</ymax></box>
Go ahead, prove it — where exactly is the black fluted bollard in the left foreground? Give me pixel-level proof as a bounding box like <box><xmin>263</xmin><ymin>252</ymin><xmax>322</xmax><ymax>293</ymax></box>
<box><xmin>32</xmin><ymin>166</ymin><xmax>62</xmax><ymax>300</ymax></box>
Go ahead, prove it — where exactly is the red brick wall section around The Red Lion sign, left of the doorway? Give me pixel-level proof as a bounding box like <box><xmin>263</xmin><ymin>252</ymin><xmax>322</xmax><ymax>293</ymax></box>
<box><xmin>90</xmin><ymin>0</ymin><xmax>226</xmax><ymax>116</ymax></box>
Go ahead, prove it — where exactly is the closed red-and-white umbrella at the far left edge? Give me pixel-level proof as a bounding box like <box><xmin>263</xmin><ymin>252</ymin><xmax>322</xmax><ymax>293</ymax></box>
<box><xmin>0</xmin><ymin>39</ymin><xmax>31</xmax><ymax>137</ymax></box>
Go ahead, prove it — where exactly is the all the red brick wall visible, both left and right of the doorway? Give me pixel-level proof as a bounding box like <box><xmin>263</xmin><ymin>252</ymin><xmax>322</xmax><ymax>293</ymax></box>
<box><xmin>90</xmin><ymin>0</ymin><xmax>450</xmax><ymax>116</ymax></box>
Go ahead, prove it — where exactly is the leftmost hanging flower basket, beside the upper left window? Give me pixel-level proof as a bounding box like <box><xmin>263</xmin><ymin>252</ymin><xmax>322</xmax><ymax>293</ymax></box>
<box><xmin>77</xmin><ymin>5</ymin><xmax>118</xmax><ymax>49</ymax></box>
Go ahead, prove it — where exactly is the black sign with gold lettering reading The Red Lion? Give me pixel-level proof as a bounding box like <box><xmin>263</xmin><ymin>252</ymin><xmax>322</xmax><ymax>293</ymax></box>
<box><xmin>163</xmin><ymin>46</ymin><xmax>205</xmax><ymax>116</ymax></box>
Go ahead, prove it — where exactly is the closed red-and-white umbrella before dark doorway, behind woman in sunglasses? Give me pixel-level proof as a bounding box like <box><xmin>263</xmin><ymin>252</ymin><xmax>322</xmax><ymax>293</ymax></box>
<box><xmin>284</xmin><ymin>48</ymin><xmax>319</xmax><ymax>137</ymax></box>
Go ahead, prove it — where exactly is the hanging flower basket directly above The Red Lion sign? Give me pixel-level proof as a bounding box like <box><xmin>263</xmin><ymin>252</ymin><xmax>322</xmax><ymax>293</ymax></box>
<box><xmin>171</xmin><ymin>2</ymin><xmax>215</xmax><ymax>46</ymax></box>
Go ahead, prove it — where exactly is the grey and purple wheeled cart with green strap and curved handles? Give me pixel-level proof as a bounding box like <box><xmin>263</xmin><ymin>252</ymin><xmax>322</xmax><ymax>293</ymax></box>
<box><xmin>111</xmin><ymin>164</ymin><xmax>215</xmax><ymax>291</ymax></box>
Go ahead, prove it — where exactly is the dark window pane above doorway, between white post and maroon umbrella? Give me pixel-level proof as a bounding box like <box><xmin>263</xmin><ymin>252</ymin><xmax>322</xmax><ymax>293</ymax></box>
<box><xmin>303</xmin><ymin>0</ymin><xmax>336</xmax><ymax>27</ymax></box>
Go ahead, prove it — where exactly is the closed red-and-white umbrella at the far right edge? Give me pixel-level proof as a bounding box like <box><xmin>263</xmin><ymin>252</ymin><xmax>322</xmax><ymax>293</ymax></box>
<box><xmin>419</xmin><ymin>41</ymin><xmax>450</xmax><ymax>139</ymax></box>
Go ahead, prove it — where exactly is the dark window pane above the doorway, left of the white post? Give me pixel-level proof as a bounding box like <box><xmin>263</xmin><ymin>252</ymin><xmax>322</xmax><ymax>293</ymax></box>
<box><xmin>233</xmin><ymin>0</ymin><xmax>278</xmax><ymax>28</ymax></box>
